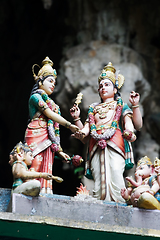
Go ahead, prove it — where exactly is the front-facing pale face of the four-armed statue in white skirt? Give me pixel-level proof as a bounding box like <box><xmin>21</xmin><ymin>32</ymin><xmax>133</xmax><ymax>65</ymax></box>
<box><xmin>98</xmin><ymin>78</ymin><xmax>117</xmax><ymax>101</ymax></box>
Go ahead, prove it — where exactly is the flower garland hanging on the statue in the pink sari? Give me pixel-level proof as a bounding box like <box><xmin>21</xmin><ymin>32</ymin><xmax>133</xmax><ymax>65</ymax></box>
<box><xmin>36</xmin><ymin>89</ymin><xmax>61</xmax><ymax>147</ymax></box>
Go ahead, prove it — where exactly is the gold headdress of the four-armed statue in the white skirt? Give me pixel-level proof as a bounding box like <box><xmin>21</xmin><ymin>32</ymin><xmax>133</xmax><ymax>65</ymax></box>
<box><xmin>98</xmin><ymin>62</ymin><xmax>124</xmax><ymax>89</ymax></box>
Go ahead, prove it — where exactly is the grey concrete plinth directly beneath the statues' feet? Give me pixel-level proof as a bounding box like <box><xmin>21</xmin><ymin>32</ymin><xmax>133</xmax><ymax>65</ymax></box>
<box><xmin>7</xmin><ymin>194</ymin><xmax>160</xmax><ymax>231</ymax></box>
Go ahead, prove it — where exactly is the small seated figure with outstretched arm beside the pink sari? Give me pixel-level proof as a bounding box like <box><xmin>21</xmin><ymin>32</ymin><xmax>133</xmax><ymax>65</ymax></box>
<box><xmin>9</xmin><ymin>142</ymin><xmax>63</xmax><ymax>197</ymax></box>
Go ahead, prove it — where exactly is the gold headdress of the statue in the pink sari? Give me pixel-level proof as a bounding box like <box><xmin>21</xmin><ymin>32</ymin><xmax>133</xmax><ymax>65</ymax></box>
<box><xmin>32</xmin><ymin>57</ymin><xmax>57</xmax><ymax>81</ymax></box>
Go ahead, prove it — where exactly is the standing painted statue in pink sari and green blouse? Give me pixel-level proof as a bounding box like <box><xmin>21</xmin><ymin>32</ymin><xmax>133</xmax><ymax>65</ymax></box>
<box><xmin>25</xmin><ymin>57</ymin><xmax>79</xmax><ymax>194</ymax></box>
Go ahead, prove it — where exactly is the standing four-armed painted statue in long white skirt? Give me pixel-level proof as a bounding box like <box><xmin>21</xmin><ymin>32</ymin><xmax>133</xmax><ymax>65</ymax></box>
<box><xmin>70</xmin><ymin>62</ymin><xmax>142</xmax><ymax>202</ymax></box>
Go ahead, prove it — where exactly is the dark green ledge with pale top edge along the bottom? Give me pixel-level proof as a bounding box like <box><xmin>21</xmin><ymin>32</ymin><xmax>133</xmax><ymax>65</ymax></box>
<box><xmin>0</xmin><ymin>213</ymin><xmax>160</xmax><ymax>240</ymax></box>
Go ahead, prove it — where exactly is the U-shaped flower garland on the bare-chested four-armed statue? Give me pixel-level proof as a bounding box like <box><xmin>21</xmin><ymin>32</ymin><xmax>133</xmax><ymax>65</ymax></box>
<box><xmin>88</xmin><ymin>97</ymin><xmax>123</xmax><ymax>149</ymax></box>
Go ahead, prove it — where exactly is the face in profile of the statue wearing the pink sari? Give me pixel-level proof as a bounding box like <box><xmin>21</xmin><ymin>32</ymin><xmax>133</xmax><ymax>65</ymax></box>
<box><xmin>39</xmin><ymin>76</ymin><xmax>56</xmax><ymax>95</ymax></box>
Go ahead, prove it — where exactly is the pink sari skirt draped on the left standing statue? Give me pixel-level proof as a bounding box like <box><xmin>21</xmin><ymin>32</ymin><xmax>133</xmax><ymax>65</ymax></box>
<box><xmin>25</xmin><ymin>115</ymin><xmax>54</xmax><ymax>194</ymax></box>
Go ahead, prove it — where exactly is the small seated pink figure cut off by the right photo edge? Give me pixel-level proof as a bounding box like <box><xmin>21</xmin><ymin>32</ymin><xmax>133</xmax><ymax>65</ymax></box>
<box><xmin>121</xmin><ymin>156</ymin><xmax>160</xmax><ymax>210</ymax></box>
